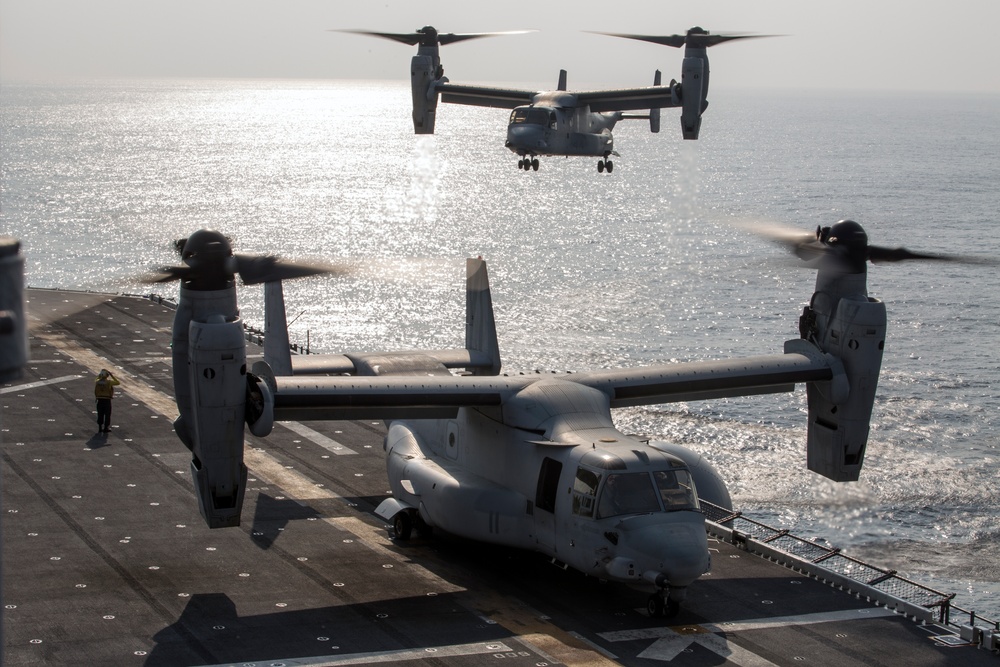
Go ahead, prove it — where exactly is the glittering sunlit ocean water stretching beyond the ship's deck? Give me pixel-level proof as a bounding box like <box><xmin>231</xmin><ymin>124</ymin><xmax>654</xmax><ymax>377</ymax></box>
<box><xmin>0</xmin><ymin>80</ymin><xmax>1000</xmax><ymax>618</ymax></box>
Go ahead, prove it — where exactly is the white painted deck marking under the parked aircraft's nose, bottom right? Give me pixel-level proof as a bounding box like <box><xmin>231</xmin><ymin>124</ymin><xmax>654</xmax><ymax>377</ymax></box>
<box><xmin>597</xmin><ymin>607</ymin><xmax>896</xmax><ymax>667</ymax></box>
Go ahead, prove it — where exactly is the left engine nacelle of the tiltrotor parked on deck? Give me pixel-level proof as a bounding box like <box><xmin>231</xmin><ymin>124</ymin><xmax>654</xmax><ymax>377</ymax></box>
<box><xmin>188</xmin><ymin>315</ymin><xmax>247</xmax><ymax>528</ymax></box>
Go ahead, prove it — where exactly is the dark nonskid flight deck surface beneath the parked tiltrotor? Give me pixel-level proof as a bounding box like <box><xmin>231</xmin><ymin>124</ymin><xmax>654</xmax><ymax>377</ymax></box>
<box><xmin>0</xmin><ymin>290</ymin><xmax>997</xmax><ymax>666</ymax></box>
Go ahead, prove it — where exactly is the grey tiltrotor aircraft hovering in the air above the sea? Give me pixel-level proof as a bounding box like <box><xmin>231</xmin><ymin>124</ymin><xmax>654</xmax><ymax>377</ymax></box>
<box><xmin>340</xmin><ymin>26</ymin><xmax>760</xmax><ymax>173</ymax></box>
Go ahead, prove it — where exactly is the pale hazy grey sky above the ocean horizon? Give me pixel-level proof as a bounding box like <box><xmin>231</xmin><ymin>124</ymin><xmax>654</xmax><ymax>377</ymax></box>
<box><xmin>0</xmin><ymin>0</ymin><xmax>1000</xmax><ymax>96</ymax></box>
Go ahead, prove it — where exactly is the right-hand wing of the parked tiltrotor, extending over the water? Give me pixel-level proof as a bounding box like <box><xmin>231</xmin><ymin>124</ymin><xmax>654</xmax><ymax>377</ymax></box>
<box><xmin>573</xmin><ymin>348</ymin><xmax>834</xmax><ymax>408</ymax></box>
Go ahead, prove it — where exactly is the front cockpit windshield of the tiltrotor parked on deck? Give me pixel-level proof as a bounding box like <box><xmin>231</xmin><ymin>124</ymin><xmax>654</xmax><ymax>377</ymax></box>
<box><xmin>597</xmin><ymin>470</ymin><xmax>698</xmax><ymax>518</ymax></box>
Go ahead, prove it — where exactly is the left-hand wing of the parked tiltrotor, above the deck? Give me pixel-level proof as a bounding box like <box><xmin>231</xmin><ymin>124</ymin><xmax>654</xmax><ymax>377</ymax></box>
<box><xmin>266</xmin><ymin>375</ymin><xmax>531</xmax><ymax>421</ymax></box>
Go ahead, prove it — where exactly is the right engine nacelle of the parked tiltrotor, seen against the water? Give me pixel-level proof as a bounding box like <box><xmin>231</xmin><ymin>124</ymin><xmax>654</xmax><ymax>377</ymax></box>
<box><xmin>804</xmin><ymin>294</ymin><xmax>886</xmax><ymax>482</ymax></box>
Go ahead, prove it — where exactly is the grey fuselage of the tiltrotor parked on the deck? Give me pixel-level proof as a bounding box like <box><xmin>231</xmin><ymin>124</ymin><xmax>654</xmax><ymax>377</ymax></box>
<box><xmin>380</xmin><ymin>379</ymin><xmax>716</xmax><ymax>603</ymax></box>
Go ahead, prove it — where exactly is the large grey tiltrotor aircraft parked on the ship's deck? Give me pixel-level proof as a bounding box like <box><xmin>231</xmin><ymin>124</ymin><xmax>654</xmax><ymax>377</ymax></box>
<box><xmin>155</xmin><ymin>226</ymin><xmax>980</xmax><ymax>615</ymax></box>
